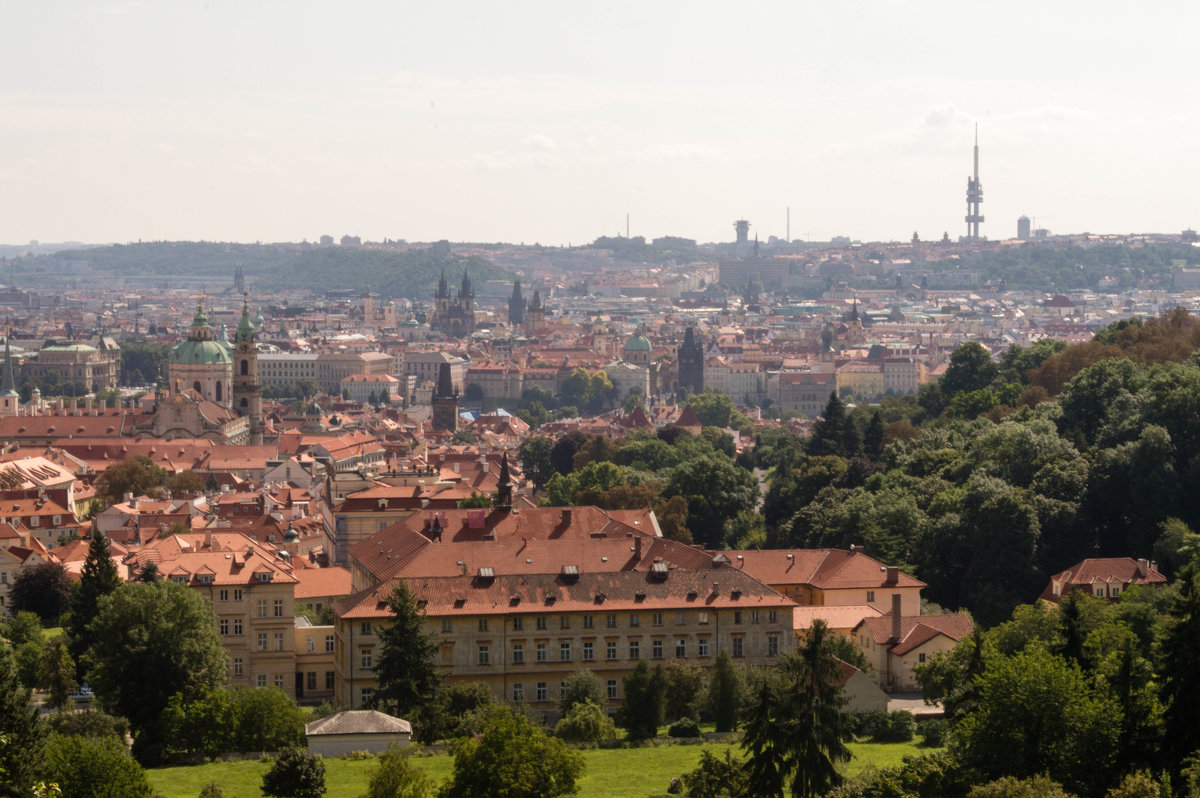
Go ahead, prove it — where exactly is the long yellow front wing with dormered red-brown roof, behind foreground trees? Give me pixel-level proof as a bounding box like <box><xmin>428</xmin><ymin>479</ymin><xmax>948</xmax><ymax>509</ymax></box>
<box><xmin>334</xmin><ymin>557</ymin><xmax>796</xmax><ymax>718</ymax></box>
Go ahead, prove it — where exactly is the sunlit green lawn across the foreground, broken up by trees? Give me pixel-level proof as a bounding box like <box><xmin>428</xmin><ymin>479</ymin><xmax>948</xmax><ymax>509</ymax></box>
<box><xmin>148</xmin><ymin>743</ymin><xmax>922</xmax><ymax>798</ymax></box>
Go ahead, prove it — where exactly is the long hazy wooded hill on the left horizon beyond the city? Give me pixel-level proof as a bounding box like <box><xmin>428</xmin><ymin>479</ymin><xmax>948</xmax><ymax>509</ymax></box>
<box><xmin>22</xmin><ymin>241</ymin><xmax>515</xmax><ymax>299</ymax></box>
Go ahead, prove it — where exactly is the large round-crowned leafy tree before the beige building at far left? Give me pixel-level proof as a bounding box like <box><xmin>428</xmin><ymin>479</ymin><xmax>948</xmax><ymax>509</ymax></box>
<box><xmin>86</xmin><ymin>581</ymin><xmax>229</xmax><ymax>763</ymax></box>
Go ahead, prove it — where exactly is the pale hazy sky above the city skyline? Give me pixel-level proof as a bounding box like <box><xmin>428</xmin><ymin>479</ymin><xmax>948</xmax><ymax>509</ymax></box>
<box><xmin>0</xmin><ymin>0</ymin><xmax>1200</xmax><ymax>244</ymax></box>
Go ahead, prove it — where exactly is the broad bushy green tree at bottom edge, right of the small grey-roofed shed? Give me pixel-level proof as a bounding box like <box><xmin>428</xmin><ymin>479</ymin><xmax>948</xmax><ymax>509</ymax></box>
<box><xmin>442</xmin><ymin>708</ymin><xmax>583</xmax><ymax>798</ymax></box>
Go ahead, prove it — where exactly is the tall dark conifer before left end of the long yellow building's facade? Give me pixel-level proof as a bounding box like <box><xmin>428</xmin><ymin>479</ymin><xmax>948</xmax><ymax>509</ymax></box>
<box><xmin>370</xmin><ymin>580</ymin><xmax>442</xmax><ymax>718</ymax></box>
